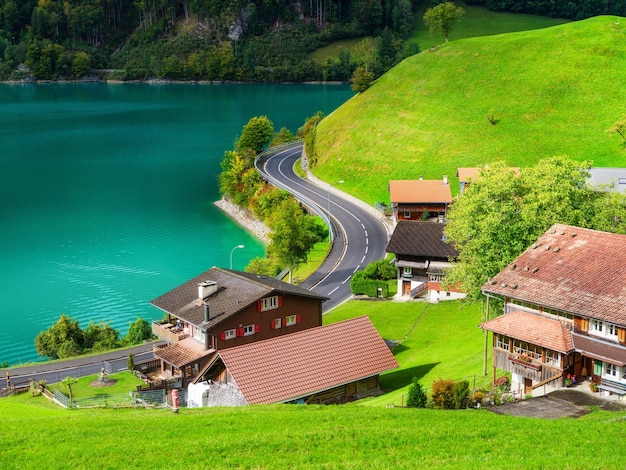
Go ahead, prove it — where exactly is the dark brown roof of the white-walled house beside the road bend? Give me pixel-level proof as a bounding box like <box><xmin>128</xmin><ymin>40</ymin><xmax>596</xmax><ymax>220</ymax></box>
<box><xmin>387</xmin><ymin>220</ymin><xmax>459</xmax><ymax>259</ymax></box>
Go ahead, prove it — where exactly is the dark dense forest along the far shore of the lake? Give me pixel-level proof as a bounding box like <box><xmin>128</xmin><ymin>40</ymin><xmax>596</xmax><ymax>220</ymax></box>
<box><xmin>0</xmin><ymin>0</ymin><xmax>626</xmax><ymax>82</ymax></box>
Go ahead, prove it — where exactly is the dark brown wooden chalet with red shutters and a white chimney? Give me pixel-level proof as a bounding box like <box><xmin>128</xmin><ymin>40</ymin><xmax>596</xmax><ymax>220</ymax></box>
<box><xmin>151</xmin><ymin>268</ymin><xmax>327</xmax><ymax>386</ymax></box>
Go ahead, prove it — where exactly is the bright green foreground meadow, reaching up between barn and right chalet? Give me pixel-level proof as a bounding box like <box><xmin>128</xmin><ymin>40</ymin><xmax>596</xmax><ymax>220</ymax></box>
<box><xmin>0</xmin><ymin>301</ymin><xmax>626</xmax><ymax>469</ymax></box>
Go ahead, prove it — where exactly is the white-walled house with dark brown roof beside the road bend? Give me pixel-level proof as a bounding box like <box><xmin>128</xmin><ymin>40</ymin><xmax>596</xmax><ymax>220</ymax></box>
<box><xmin>387</xmin><ymin>220</ymin><xmax>465</xmax><ymax>302</ymax></box>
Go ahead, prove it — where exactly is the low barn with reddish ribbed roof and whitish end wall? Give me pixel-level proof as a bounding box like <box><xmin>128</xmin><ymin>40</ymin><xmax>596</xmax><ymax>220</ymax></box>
<box><xmin>187</xmin><ymin>317</ymin><xmax>398</xmax><ymax>407</ymax></box>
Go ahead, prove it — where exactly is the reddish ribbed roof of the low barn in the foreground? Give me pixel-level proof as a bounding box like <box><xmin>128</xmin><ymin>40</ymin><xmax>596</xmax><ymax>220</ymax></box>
<box><xmin>212</xmin><ymin>317</ymin><xmax>398</xmax><ymax>404</ymax></box>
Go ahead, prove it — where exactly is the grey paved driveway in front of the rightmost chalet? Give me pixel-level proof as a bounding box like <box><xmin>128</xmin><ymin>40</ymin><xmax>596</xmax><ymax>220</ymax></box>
<box><xmin>487</xmin><ymin>389</ymin><xmax>626</xmax><ymax>419</ymax></box>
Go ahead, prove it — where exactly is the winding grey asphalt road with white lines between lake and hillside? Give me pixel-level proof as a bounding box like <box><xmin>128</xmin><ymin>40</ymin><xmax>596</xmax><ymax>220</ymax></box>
<box><xmin>255</xmin><ymin>144</ymin><xmax>389</xmax><ymax>312</ymax></box>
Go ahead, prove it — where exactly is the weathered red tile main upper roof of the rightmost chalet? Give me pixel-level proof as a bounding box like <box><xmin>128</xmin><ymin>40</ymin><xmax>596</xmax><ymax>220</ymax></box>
<box><xmin>483</xmin><ymin>224</ymin><xmax>626</xmax><ymax>326</ymax></box>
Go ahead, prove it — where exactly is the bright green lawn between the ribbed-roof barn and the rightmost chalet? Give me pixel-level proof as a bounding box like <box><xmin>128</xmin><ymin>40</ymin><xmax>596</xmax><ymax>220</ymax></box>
<box><xmin>323</xmin><ymin>301</ymin><xmax>491</xmax><ymax>406</ymax></box>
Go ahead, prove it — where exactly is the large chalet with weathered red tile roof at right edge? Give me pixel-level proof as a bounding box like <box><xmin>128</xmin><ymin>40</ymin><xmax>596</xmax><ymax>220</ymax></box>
<box><xmin>480</xmin><ymin>224</ymin><xmax>626</xmax><ymax>396</ymax></box>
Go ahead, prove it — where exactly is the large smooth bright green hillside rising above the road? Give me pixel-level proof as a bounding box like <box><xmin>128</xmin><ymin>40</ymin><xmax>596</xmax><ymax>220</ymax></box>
<box><xmin>314</xmin><ymin>16</ymin><xmax>626</xmax><ymax>203</ymax></box>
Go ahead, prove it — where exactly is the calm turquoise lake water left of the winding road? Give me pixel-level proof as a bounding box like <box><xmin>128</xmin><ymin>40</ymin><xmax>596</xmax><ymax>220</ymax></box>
<box><xmin>0</xmin><ymin>83</ymin><xmax>352</xmax><ymax>364</ymax></box>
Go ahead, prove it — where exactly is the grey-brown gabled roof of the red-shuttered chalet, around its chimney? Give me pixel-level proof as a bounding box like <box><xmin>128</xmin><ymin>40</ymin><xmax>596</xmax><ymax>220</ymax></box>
<box><xmin>150</xmin><ymin>268</ymin><xmax>327</xmax><ymax>328</ymax></box>
